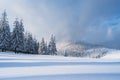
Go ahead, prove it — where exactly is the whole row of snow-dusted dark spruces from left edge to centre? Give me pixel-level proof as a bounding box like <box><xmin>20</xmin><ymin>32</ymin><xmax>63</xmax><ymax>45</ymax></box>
<box><xmin>0</xmin><ymin>11</ymin><xmax>57</xmax><ymax>55</ymax></box>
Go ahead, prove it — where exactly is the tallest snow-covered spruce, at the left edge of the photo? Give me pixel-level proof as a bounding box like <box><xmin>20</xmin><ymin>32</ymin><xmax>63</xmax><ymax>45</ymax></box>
<box><xmin>0</xmin><ymin>11</ymin><xmax>11</xmax><ymax>51</ymax></box>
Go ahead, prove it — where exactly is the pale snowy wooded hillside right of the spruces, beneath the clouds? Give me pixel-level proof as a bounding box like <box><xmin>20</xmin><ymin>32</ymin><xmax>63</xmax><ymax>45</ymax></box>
<box><xmin>57</xmin><ymin>41</ymin><xmax>110</xmax><ymax>58</ymax></box>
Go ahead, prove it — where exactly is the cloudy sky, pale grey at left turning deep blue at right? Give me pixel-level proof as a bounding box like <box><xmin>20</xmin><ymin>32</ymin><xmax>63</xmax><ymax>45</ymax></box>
<box><xmin>0</xmin><ymin>0</ymin><xmax>120</xmax><ymax>48</ymax></box>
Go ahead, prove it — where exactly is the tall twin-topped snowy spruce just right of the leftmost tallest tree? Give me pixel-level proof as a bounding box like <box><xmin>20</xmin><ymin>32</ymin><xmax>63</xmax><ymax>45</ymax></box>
<box><xmin>11</xmin><ymin>19</ymin><xmax>24</xmax><ymax>53</ymax></box>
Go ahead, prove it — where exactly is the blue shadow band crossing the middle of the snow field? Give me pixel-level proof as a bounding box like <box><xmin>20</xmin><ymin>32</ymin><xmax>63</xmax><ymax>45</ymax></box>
<box><xmin>0</xmin><ymin>62</ymin><xmax>120</xmax><ymax>68</ymax></box>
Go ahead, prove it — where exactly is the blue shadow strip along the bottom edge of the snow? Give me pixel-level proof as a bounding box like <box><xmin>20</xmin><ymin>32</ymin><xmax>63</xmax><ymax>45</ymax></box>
<box><xmin>1</xmin><ymin>74</ymin><xmax>120</xmax><ymax>80</ymax></box>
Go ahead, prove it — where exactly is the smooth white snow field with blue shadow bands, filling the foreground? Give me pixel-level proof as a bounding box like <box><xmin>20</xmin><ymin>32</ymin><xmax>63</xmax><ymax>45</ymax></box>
<box><xmin>0</xmin><ymin>51</ymin><xmax>120</xmax><ymax>80</ymax></box>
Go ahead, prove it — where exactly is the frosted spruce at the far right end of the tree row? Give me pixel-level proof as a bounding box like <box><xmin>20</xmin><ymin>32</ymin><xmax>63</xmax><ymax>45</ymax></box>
<box><xmin>48</xmin><ymin>35</ymin><xmax>57</xmax><ymax>55</ymax></box>
